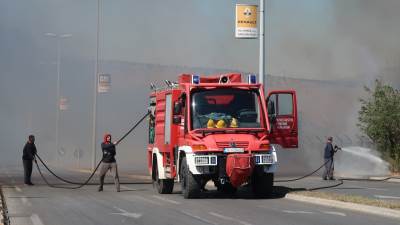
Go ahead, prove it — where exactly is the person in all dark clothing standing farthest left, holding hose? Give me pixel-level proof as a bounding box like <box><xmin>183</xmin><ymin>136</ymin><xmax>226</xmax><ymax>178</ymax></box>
<box><xmin>22</xmin><ymin>135</ymin><xmax>37</xmax><ymax>185</ymax></box>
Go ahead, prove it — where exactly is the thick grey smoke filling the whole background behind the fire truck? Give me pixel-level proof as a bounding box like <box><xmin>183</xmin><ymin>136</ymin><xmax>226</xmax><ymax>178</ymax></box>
<box><xmin>0</xmin><ymin>0</ymin><xmax>400</xmax><ymax>176</ymax></box>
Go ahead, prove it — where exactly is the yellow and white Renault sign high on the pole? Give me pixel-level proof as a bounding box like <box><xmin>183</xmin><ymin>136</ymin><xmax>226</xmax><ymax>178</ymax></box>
<box><xmin>235</xmin><ymin>4</ymin><xmax>258</xmax><ymax>38</ymax></box>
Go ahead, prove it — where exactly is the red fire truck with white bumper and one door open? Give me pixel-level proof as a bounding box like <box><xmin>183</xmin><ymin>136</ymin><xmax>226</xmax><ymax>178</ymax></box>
<box><xmin>147</xmin><ymin>74</ymin><xmax>298</xmax><ymax>198</ymax></box>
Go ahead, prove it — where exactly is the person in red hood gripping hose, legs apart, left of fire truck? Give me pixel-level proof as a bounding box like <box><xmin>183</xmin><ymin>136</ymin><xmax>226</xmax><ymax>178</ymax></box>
<box><xmin>98</xmin><ymin>134</ymin><xmax>120</xmax><ymax>192</ymax></box>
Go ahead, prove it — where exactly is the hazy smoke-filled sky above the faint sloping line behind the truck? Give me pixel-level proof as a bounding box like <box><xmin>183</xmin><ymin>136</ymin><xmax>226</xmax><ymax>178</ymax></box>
<box><xmin>0</xmin><ymin>0</ymin><xmax>400</xmax><ymax>79</ymax></box>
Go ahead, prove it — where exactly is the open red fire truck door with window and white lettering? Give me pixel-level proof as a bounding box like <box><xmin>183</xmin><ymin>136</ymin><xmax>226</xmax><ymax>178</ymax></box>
<box><xmin>267</xmin><ymin>90</ymin><xmax>298</xmax><ymax>148</ymax></box>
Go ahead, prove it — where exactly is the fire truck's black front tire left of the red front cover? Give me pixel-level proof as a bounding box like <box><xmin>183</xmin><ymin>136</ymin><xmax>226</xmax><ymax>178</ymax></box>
<box><xmin>180</xmin><ymin>157</ymin><xmax>200</xmax><ymax>198</ymax></box>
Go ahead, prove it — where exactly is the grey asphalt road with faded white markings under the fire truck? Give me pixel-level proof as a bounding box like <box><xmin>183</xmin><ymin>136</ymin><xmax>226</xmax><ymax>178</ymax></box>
<box><xmin>0</xmin><ymin>168</ymin><xmax>399</xmax><ymax>225</ymax></box>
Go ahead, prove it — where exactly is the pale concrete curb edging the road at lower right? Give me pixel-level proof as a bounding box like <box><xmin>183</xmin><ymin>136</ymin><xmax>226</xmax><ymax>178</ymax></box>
<box><xmin>285</xmin><ymin>194</ymin><xmax>400</xmax><ymax>220</ymax></box>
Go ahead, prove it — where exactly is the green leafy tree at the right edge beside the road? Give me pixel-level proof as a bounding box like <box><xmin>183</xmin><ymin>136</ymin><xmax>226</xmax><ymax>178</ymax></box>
<box><xmin>358</xmin><ymin>80</ymin><xmax>400</xmax><ymax>172</ymax></box>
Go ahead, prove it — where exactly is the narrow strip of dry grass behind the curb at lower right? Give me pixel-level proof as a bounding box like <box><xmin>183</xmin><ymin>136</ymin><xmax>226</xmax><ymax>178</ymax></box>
<box><xmin>294</xmin><ymin>191</ymin><xmax>400</xmax><ymax>211</ymax></box>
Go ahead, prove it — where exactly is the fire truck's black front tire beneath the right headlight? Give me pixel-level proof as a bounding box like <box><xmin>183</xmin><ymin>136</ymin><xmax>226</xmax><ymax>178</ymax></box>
<box><xmin>252</xmin><ymin>170</ymin><xmax>274</xmax><ymax>198</ymax></box>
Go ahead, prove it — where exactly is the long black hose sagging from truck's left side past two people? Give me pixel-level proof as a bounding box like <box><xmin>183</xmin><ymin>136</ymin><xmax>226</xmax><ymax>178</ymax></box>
<box><xmin>34</xmin><ymin>112</ymin><xmax>150</xmax><ymax>189</ymax></box>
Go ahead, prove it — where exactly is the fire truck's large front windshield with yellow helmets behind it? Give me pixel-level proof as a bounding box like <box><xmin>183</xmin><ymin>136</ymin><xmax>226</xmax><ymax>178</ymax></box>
<box><xmin>191</xmin><ymin>88</ymin><xmax>262</xmax><ymax>129</ymax></box>
